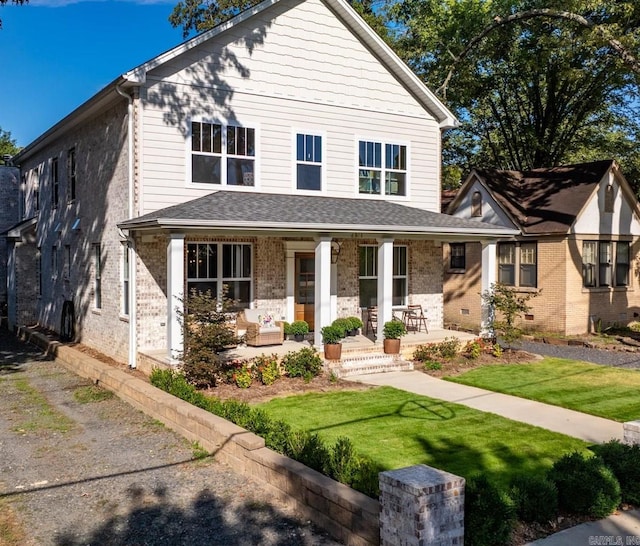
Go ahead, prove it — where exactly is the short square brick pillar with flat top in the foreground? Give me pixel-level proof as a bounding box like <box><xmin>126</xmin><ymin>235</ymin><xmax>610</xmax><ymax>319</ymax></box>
<box><xmin>380</xmin><ymin>465</ymin><xmax>465</xmax><ymax>546</ymax></box>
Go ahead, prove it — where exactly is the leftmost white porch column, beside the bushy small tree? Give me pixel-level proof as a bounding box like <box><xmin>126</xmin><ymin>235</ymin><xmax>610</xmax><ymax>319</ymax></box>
<box><xmin>167</xmin><ymin>233</ymin><xmax>185</xmax><ymax>360</ymax></box>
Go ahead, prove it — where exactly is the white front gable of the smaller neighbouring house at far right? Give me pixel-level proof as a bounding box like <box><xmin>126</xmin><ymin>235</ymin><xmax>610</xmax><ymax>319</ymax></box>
<box><xmin>571</xmin><ymin>173</ymin><xmax>640</xmax><ymax>235</ymax></box>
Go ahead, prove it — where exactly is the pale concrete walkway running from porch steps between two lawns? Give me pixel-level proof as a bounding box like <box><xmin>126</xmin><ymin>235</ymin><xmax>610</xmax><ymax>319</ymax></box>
<box><xmin>346</xmin><ymin>372</ymin><xmax>623</xmax><ymax>443</ymax></box>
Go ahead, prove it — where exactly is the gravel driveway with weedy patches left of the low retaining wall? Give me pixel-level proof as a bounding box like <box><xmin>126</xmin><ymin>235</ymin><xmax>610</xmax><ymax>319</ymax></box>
<box><xmin>0</xmin><ymin>330</ymin><xmax>339</xmax><ymax>546</ymax></box>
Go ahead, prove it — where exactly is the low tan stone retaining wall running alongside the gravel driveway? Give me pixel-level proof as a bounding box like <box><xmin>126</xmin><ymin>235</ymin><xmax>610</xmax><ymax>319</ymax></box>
<box><xmin>18</xmin><ymin>329</ymin><xmax>380</xmax><ymax>546</ymax></box>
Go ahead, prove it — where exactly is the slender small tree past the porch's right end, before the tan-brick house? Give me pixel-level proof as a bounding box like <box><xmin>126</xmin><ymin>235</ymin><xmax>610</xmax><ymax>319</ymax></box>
<box><xmin>482</xmin><ymin>283</ymin><xmax>536</xmax><ymax>346</ymax></box>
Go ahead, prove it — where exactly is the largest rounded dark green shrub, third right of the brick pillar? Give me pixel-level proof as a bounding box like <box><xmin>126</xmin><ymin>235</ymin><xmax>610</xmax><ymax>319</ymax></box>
<box><xmin>548</xmin><ymin>452</ymin><xmax>620</xmax><ymax>518</ymax></box>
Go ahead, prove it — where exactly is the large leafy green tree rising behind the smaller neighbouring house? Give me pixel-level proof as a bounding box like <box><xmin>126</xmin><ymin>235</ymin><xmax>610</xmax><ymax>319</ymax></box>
<box><xmin>386</xmin><ymin>0</ymin><xmax>640</xmax><ymax>184</ymax></box>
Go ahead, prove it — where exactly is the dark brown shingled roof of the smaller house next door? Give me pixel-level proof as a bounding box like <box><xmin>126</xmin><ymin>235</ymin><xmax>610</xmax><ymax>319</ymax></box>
<box><xmin>448</xmin><ymin>160</ymin><xmax>617</xmax><ymax>235</ymax></box>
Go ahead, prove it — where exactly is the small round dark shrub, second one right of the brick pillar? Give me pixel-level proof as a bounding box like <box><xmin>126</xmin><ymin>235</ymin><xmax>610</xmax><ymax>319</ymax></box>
<box><xmin>510</xmin><ymin>475</ymin><xmax>558</xmax><ymax>523</ymax></box>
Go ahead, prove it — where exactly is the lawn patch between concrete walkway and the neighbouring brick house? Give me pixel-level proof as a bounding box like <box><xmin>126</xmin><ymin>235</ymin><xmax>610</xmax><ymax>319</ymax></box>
<box><xmin>445</xmin><ymin>358</ymin><xmax>640</xmax><ymax>422</ymax></box>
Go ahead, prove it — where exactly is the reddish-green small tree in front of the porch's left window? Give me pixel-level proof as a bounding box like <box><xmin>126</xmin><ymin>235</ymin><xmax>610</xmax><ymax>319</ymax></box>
<box><xmin>178</xmin><ymin>290</ymin><xmax>240</xmax><ymax>388</ymax></box>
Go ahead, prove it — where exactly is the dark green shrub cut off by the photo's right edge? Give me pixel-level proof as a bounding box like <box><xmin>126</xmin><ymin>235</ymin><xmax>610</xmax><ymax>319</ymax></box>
<box><xmin>591</xmin><ymin>440</ymin><xmax>640</xmax><ymax>506</ymax></box>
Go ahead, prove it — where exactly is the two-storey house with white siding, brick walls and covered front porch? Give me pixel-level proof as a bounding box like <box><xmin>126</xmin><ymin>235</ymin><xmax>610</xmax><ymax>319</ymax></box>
<box><xmin>10</xmin><ymin>0</ymin><xmax>516</xmax><ymax>366</ymax></box>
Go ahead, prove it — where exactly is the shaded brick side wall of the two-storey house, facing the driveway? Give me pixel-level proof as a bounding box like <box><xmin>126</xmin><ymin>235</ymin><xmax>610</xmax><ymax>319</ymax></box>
<box><xmin>17</xmin><ymin>99</ymin><xmax>129</xmax><ymax>362</ymax></box>
